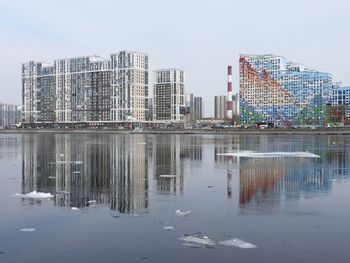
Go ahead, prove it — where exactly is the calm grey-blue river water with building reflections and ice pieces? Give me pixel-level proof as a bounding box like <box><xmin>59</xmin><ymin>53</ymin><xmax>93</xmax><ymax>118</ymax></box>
<box><xmin>0</xmin><ymin>134</ymin><xmax>350</xmax><ymax>262</ymax></box>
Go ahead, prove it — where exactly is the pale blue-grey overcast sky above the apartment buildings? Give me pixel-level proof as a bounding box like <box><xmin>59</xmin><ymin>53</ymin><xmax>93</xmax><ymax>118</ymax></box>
<box><xmin>0</xmin><ymin>0</ymin><xmax>350</xmax><ymax>116</ymax></box>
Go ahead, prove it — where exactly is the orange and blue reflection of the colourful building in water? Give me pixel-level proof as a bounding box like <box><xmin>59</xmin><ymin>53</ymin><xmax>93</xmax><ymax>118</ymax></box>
<box><xmin>239</xmin><ymin>158</ymin><xmax>331</xmax><ymax>207</ymax></box>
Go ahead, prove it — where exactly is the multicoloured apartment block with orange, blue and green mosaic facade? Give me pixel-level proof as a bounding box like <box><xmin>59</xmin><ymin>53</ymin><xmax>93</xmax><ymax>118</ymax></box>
<box><xmin>239</xmin><ymin>55</ymin><xmax>332</xmax><ymax>124</ymax></box>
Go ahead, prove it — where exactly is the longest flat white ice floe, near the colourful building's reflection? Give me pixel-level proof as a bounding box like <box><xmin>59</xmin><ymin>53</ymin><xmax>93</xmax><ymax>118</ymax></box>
<box><xmin>217</xmin><ymin>151</ymin><xmax>320</xmax><ymax>158</ymax></box>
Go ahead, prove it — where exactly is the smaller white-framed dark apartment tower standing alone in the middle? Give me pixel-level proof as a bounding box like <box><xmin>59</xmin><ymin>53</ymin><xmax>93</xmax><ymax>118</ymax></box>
<box><xmin>153</xmin><ymin>69</ymin><xmax>185</xmax><ymax>121</ymax></box>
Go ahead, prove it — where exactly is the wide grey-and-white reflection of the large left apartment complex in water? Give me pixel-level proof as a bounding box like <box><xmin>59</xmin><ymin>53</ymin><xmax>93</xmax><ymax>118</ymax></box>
<box><xmin>23</xmin><ymin>134</ymin><xmax>148</xmax><ymax>213</ymax></box>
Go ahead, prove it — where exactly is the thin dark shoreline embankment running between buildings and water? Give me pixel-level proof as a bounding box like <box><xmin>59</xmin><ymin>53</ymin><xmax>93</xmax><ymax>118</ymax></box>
<box><xmin>0</xmin><ymin>128</ymin><xmax>350</xmax><ymax>135</ymax></box>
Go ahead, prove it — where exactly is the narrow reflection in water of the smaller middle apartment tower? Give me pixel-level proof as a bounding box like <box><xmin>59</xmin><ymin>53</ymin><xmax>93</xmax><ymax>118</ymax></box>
<box><xmin>152</xmin><ymin>135</ymin><xmax>184</xmax><ymax>194</ymax></box>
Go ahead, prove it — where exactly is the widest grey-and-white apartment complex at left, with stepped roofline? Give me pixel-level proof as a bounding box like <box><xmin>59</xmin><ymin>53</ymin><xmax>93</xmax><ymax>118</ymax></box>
<box><xmin>22</xmin><ymin>51</ymin><xmax>148</xmax><ymax>123</ymax></box>
